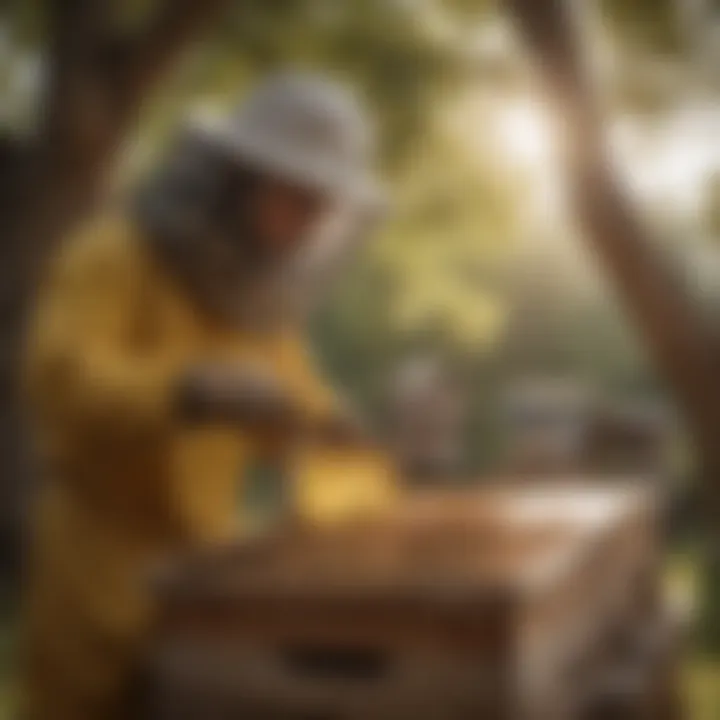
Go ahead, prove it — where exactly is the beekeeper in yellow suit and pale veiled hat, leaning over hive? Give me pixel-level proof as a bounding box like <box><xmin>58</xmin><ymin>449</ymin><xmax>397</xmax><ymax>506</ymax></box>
<box><xmin>22</xmin><ymin>73</ymin><xmax>381</xmax><ymax>720</ymax></box>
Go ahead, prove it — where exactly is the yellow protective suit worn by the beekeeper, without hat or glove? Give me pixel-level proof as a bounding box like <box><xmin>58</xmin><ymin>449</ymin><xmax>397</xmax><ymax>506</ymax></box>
<box><xmin>22</xmin><ymin>218</ymin><xmax>340</xmax><ymax>720</ymax></box>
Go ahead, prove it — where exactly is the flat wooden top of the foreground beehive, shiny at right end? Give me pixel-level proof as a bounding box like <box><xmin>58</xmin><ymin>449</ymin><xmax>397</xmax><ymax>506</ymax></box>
<box><xmin>156</xmin><ymin>484</ymin><xmax>648</xmax><ymax>603</ymax></box>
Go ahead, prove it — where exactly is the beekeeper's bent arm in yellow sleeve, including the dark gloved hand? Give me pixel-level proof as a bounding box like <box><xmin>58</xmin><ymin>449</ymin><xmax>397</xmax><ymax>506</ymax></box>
<box><xmin>28</xmin><ymin>228</ymin><xmax>342</xmax><ymax>444</ymax></box>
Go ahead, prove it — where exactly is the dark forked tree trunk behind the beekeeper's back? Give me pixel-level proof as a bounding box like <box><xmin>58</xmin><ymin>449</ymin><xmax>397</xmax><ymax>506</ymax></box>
<box><xmin>0</xmin><ymin>0</ymin><xmax>229</xmax><ymax>583</ymax></box>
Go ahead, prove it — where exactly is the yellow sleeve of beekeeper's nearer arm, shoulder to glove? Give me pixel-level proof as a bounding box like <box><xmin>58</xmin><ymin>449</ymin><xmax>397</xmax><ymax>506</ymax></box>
<box><xmin>27</xmin><ymin>219</ymin><xmax>181</xmax><ymax>435</ymax></box>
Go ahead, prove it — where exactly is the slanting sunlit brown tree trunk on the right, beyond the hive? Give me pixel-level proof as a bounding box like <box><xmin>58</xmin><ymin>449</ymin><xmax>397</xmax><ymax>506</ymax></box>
<box><xmin>505</xmin><ymin>0</ymin><xmax>720</xmax><ymax>648</ymax></box>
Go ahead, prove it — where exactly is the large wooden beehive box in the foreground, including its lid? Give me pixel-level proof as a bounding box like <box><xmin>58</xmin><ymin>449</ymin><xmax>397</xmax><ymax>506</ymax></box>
<box><xmin>153</xmin><ymin>483</ymin><xmax>656</xmax><ymax>720</ymax></box>
